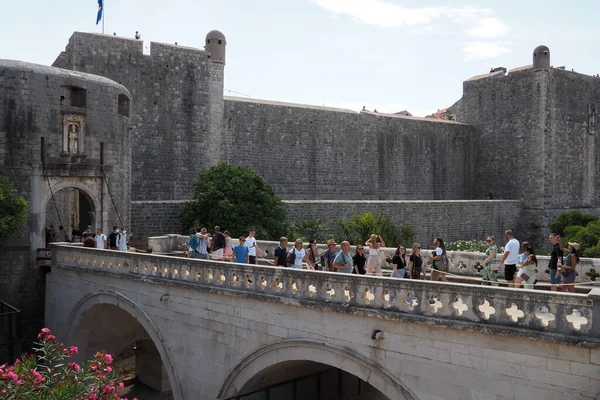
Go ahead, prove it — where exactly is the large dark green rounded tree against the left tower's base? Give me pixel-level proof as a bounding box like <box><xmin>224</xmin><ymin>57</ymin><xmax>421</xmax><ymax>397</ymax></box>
<box><xmin>182</xmin><ymin>163</ymin><xmax>286</xmax><ymax>240</ymax></box>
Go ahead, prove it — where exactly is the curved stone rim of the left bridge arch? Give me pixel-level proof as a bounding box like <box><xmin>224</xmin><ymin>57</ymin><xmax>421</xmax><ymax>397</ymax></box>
<box><xmin>67</xmin><ymin>290</ymin><xmax>183</xmax><ymax>400</ymax></box>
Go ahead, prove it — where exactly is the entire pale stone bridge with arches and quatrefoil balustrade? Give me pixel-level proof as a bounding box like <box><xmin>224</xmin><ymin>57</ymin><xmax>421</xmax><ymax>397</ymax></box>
<box><xmin>46</xmin><ymin>246</ymin><xmax>600</xmax><ymax>400</ymax></box>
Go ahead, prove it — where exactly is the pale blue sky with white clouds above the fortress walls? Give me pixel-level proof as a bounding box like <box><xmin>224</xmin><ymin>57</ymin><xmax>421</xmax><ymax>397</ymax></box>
<box><xmin>0</xmin><ymin>0</ymin><xmax>600</xmax><ymax>116</ymax></box>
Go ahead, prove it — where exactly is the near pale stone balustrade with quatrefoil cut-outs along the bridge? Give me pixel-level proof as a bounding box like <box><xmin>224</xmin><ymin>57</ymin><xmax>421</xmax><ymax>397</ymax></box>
<box><xmin>52</xmin><ymin>245</ymin><xmax>600</xmax><ymax>343</ymax></box>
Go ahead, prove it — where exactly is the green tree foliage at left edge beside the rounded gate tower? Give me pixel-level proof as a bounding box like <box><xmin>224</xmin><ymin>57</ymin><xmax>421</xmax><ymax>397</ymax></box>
<box><xmin>0</xmin><ymin>176</ymin><xmax>29</xmax><ymax>246</ymax></box>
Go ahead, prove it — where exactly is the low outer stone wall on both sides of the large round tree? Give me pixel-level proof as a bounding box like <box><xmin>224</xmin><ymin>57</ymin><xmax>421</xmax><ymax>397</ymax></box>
<box><xmin>131</xmin><ymin>200</ymin><xmax>525</xmax><ymax>243</ymax></box>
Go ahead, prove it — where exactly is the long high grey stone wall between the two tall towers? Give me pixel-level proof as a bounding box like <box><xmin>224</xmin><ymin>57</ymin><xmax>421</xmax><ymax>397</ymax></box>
<box><xmin>223</xmin><ymin>98</ymin><xmax>475</xmax><ymax>200</ymax></box>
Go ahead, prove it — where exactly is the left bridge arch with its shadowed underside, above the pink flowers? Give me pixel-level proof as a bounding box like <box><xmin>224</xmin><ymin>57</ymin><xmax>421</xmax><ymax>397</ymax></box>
<box><xmin>66</xmin><ymin>290</ymin><xmax>183</xmax><ymax>400</ymax></box>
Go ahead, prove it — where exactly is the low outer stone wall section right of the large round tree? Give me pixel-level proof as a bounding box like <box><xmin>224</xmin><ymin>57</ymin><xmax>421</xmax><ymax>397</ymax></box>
<box><xmin>285</xmin><ymin>200</ymin><xmax>523</xmax><ymax>247</ymax></box>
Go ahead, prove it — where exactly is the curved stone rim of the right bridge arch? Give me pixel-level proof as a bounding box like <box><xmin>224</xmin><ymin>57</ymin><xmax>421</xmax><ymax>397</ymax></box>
<box><xmin>218</xmin><ymin>339</ymin><xmax>417</xmax><ymax>400</ymax></box>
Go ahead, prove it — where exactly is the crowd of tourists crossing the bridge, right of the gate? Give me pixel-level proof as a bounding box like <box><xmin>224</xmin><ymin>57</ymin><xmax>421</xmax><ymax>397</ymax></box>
<box><xmin>187</xmin><ymin>226</ymin><xmax>580</xmax><ymax>292</ymax></box>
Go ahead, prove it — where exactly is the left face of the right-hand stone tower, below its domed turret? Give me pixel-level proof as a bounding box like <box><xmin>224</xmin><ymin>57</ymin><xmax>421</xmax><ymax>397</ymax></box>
<box><xmin>461</xmin><ymin>69</ymin><xmax>548</xmax><ymax>207</ymax></box>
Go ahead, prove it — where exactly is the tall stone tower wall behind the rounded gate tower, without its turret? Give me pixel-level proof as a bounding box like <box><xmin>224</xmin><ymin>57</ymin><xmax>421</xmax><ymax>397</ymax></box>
<box><xmin>55</xmin><ymin>32</ymin><xmax>223</xmax><ymax>201</ymax></box>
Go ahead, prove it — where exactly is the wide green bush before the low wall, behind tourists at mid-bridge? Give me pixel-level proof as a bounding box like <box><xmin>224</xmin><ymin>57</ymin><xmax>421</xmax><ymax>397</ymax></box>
<box><xmin>336</xmin><ymin>212</ymin><xmax>414</xmax><ymax>247</ymax></box>
